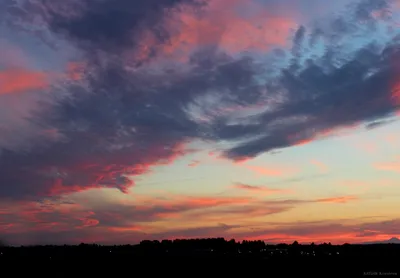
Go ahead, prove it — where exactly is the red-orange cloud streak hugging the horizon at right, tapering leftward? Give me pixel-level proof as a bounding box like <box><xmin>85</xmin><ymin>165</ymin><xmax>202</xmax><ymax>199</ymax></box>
<box><xmin>137</xmin><ymin>218</ymin><xmax>399</xmax><ymax>244</ymax></box>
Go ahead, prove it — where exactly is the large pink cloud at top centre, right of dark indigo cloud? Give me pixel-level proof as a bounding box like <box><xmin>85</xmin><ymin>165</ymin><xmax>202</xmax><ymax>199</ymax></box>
<box><xmin>131</xmin><ymin>0</ymin><xmax>297</xmax><ymax>62</ymax></box>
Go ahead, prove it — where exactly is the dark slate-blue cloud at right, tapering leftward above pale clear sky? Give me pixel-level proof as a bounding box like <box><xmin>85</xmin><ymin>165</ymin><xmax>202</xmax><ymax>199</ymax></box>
<box><xmin>218</xmin><ymin>46</ymin><xmax>400</xmax><ymax>159</ymax></box>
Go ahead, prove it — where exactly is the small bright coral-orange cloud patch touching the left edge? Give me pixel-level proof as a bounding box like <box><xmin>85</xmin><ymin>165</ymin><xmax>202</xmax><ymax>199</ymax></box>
<box><xmin>0</xmin><ymin>68</ymin><xmax>50</xmax><ymax>95</ymax></box>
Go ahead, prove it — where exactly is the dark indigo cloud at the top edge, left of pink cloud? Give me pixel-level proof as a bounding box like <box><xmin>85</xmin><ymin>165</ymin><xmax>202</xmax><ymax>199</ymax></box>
<box><xmin>5</xmin><ymin>0</ymin><xmax>200</xmax><ymax>51</ymax></box>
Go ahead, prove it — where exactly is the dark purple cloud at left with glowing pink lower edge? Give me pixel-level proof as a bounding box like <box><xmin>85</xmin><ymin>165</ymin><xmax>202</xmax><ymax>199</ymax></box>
<box><xmin>0</xmin><ymin>50</ymin><xmax>266</xmax><ymax>198</ymax></box>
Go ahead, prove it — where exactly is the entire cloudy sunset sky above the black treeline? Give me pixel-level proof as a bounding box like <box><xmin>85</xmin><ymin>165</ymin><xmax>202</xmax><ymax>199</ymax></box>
<box><xmin>0</xmin><ymin>0</ymin><xmax>400</xmax><ymax>245</ymax></box>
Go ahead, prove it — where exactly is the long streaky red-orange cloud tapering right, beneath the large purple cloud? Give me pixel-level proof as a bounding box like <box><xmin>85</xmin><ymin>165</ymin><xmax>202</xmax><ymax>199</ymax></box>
<box><xmin>0</xmin><ymin>190</ymin><xmax>366</xmax><ymax>244</ymax></box>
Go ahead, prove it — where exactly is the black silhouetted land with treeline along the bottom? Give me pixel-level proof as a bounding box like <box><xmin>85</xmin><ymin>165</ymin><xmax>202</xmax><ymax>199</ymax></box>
<box><xmin>0</xmin><ymin>239</ymin><xmax>400</xmax><ymax>277</ymax></box>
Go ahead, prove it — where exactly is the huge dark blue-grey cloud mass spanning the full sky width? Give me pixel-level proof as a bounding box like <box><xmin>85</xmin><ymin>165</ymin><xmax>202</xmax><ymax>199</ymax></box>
<box><xmin>0</xmin><ymin>0</ymin><xmax>400</xmax><ymax>202</ymax></box>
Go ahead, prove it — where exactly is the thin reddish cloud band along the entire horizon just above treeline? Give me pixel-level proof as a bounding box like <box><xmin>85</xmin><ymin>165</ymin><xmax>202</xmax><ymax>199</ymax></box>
<box><xmin>3</xmin><ymin>211</ymin><xmax>400</xmax><ymax>244</ymax></box>
